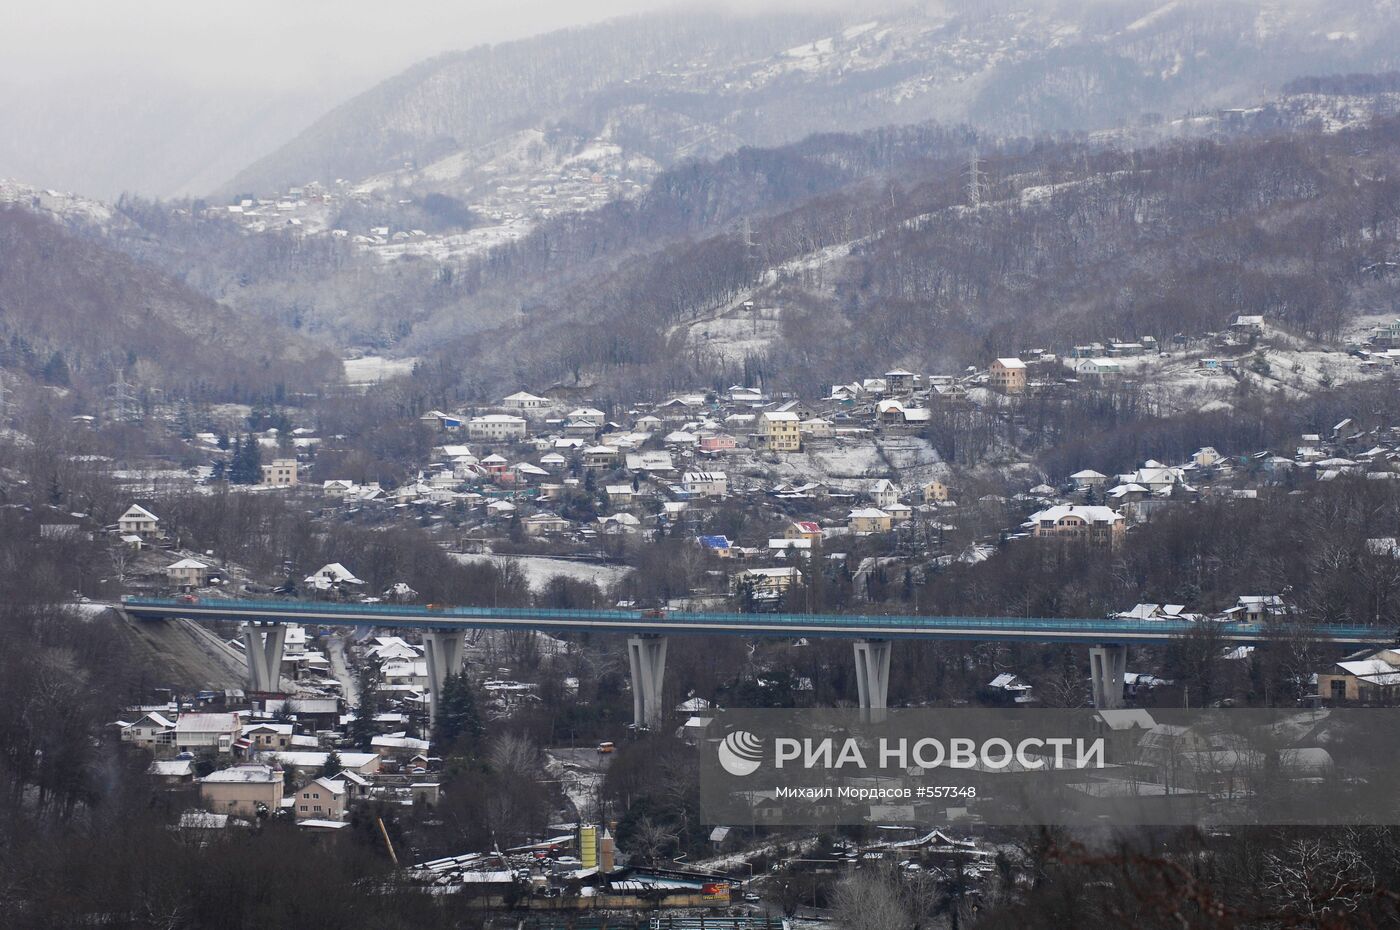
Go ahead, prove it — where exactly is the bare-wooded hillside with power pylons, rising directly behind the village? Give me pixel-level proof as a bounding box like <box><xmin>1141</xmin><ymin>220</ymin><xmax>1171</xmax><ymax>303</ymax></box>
<box><xmin>420</xmin><ymin>112</ymin><xmax>1400</xmax><ymax>391</ymax></box>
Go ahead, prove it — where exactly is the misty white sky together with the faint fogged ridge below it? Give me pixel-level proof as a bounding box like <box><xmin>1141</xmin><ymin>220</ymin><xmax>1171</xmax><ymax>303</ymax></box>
<box><xmin>0</xmin><ymin>0</ymin><xmax>697</xmax><ymax>199</ymax></box>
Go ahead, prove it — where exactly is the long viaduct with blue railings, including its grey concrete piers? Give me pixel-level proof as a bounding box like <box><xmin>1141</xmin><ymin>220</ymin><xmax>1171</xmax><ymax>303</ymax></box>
<box><xmin>122</xmin><ymin>597</ymin><xmax>1393</xmax><ymax>726</ymax></box>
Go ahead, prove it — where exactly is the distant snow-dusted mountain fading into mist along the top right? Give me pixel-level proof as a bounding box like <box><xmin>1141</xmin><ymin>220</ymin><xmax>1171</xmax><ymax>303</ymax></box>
<box><xmin>225</xmin><ymin>0</ymin><xmax>1400</xmax><ymax>199</ymax></box>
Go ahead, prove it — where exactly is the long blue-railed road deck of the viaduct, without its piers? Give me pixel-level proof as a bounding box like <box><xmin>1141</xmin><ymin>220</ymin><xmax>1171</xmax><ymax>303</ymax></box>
<box><xmin>122</xmin><ymin>597</ymin><xmax>1394</xmax><ymax>644</ymax></box>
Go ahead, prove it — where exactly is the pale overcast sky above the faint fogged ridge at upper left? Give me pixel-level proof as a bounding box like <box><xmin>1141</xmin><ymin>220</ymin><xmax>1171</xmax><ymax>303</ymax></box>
<box><xmin>0</xmin><ymin>0</ymin><xmax>672</xmax><ymax>87</ymax></box>
